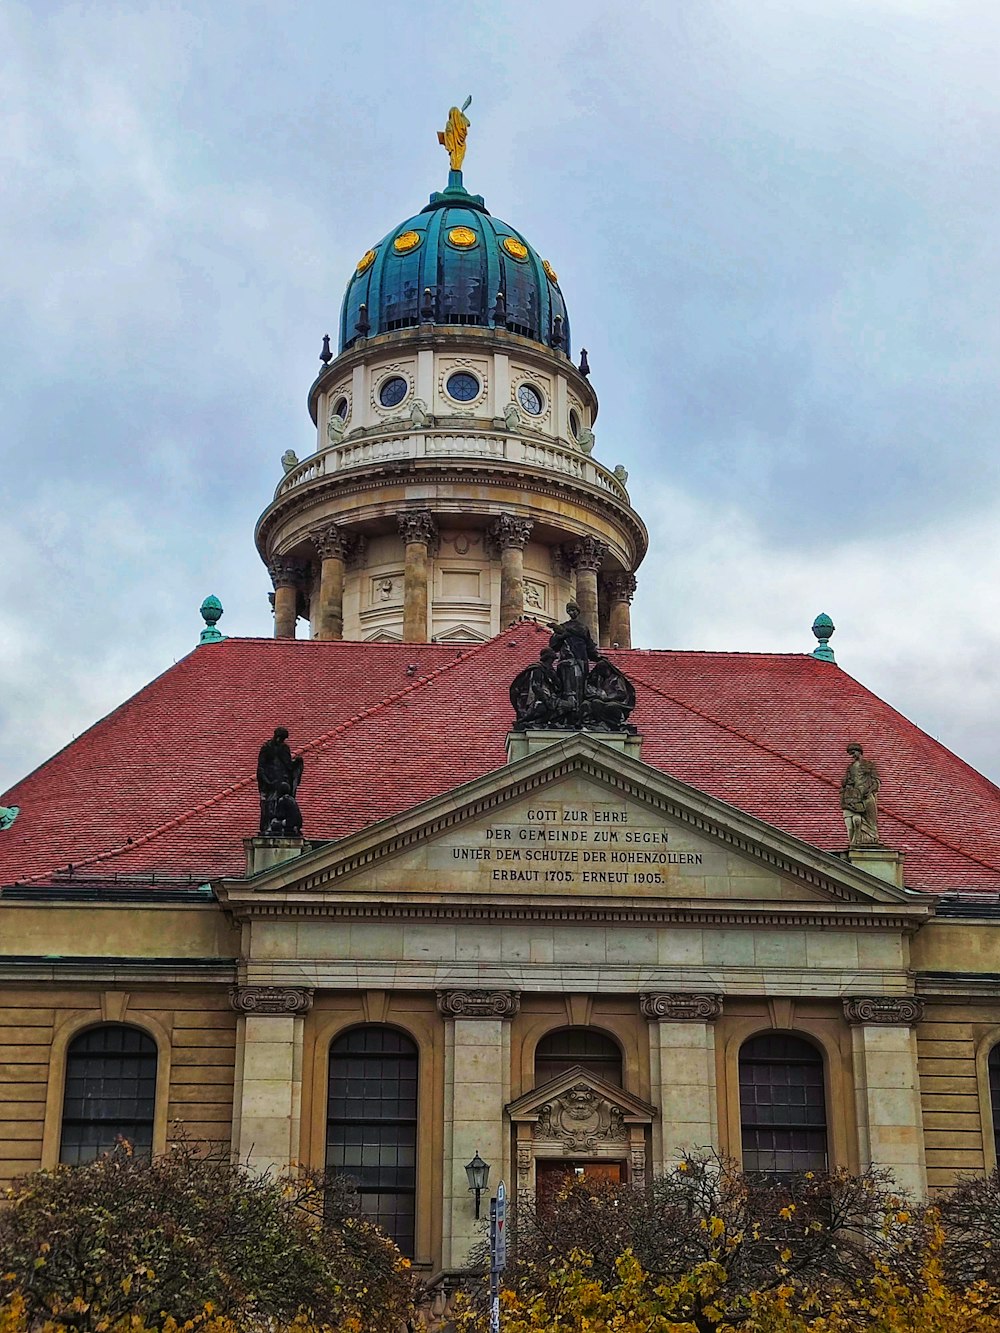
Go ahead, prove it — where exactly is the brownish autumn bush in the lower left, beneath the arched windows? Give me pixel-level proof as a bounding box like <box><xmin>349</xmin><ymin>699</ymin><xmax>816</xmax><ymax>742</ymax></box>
<box><xmin>0</xmin><ymin>1142</ymin><xmax>412</xmax><ymax>1333</ymax></box>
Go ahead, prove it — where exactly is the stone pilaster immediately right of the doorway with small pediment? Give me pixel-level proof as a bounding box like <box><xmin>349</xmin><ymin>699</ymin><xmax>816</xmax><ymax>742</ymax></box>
<box><xmin>639</xmin><ymin>990</ymin><xmax>723</xmax><ymax>1170</ymax></box>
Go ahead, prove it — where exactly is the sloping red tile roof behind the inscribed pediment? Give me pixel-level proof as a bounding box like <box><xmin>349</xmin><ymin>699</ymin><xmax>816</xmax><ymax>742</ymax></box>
<box><xmin>0</xmin><ymin>623</ymin><xmax>1000</xmax><ymax>893</ymax></box>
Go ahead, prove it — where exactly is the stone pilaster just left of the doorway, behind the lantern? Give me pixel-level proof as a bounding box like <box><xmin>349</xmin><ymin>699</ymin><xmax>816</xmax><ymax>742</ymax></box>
<box><xmin>437</xmin><ymin>990</ymin><xmax>520</xmax><ymax>1269</ymax></box>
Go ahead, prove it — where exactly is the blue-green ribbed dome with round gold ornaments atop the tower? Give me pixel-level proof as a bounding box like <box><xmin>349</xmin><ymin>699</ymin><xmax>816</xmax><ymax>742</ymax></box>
<box><xmin>340</xmin><ymin>172</ymin><xmax>569</xmax><ymax>355</ymax></box>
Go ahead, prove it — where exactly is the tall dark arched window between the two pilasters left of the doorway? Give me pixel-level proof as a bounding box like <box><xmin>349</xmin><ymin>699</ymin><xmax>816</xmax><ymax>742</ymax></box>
<box><xmin>327</xmin><ymin>1026</ymin><xmax>417</xmax><ymax>1258</ymax></box>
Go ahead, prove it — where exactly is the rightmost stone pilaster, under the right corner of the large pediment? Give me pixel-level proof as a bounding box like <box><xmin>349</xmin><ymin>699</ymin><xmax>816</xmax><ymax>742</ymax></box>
<box><xmin>844</xmin><ymin>996</ymin><xmax>927</xmax><ymax>1198</ymax></box>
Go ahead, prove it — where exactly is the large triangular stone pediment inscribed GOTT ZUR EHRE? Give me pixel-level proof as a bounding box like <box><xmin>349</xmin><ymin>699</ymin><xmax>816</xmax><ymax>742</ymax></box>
<box><xmin>220</xmin><ymin>733</ymin><xmax>929</xmax><ymax>918</ymax></box>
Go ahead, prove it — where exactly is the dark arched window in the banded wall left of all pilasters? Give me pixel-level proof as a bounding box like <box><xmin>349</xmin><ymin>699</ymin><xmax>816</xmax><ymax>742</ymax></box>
<box><xmin>59</xmin><ymin>1022</ymin><xmax>156</xmax><ymax>1164</ymax></box>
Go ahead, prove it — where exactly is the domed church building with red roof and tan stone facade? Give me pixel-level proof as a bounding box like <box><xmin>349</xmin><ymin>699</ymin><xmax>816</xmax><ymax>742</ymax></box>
<box><xmin>0</xmin><ymin>109</ymin><xmax>1000</xmax><ymax>1301</ymax></box>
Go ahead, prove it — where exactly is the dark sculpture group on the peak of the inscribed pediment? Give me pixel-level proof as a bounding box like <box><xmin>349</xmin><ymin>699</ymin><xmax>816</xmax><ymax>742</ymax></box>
<box><xmin>511</xmin><ymin>601</ymin><xmax>636</xmax><ymax>733</ymax></box>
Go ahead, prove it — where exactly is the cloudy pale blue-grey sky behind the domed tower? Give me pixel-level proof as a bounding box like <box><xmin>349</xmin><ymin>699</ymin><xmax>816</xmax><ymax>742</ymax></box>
<box><xmin>0</xmin><ymin>0</ymin><xmax>1000</xmax><ymax>789</ymax></box>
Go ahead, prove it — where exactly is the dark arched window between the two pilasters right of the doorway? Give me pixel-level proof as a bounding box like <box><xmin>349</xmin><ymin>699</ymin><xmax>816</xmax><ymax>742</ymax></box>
<box><xmin>740</xmin><ymin>1034</ymin><xmax>827</xmax><ymax>1176</ymax></box>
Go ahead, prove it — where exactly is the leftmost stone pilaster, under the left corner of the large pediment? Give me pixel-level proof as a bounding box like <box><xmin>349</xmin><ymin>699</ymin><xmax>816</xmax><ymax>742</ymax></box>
<box><xmin>229</xmin><ymin>986</ymin><xmax>312</xmax><ymax>1172</ymax></box>
